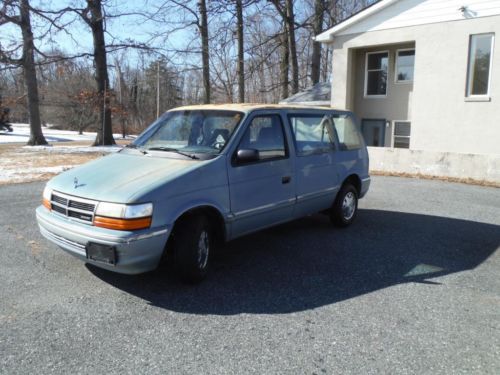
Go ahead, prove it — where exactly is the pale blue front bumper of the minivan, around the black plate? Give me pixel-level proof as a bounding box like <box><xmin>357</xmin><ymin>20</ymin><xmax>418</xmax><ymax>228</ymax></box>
<box><xmin>36</xmin><ymin>206</ymin><xmax>170</xmax><ymax>274</ymax></box>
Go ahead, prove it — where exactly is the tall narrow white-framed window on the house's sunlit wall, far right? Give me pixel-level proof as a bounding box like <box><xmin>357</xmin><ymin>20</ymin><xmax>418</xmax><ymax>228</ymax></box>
<box><xmin>467</xmin><ymin>34</ymin><xmax>493</xmax><ymax>96</ymax></box>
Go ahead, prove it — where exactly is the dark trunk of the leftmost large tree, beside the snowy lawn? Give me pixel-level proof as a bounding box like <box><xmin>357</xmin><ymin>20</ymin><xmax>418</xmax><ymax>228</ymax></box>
<box><xmin>20</xmin><ymin>0</ymin><xmax>47</xmax><ymax>146</ymax></box>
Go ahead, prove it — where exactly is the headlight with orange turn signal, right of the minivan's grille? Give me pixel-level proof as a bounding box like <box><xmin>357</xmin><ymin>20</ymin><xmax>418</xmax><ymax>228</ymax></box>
<box><xmin>94</xmin><ymin>202</ymin><xmax>153</xmax><ymax>230</ymax></box>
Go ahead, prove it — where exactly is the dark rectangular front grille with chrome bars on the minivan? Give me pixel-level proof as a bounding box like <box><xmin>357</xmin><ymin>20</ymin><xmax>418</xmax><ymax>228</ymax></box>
<box><xmin>50</xmin><ymin>192</ymin><xmax>97</xmax><ymax>224</ymax></box>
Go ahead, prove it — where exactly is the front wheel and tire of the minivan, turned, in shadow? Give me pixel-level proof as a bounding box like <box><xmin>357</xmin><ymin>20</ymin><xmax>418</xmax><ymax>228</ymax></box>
<box><xmin>173</xmin><ymin>215</ymin><xmax>214</xmax><ymax>284</ymax></box>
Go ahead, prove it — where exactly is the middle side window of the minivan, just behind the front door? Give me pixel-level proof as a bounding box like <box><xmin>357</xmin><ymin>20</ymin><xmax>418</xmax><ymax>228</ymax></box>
<box><xmin>288</xmin><ymin>115</ymin><xmax>335</xmax><ymax>156</ymax></box>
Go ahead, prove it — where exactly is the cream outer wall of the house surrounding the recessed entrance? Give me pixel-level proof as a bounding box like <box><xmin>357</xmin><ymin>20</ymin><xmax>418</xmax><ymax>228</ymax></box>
<box><xmin>332</xmin><ymin>14</ymin><xmax>500</xmax><ymax>155</ymax></box>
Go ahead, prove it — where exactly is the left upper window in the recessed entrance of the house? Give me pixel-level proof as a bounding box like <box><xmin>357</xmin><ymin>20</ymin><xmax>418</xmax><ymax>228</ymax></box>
<box><xmin>365</xmin><ymin>52</ymin><xmax>389</xmax><ymax>96</ymax></box>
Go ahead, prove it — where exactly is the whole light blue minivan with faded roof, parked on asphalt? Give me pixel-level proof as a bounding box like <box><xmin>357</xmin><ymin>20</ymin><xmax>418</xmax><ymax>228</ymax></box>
<box><xmin>36</xmin><ymin>104</ymin><xmax>370</xmax><ymax>282</ymax></box>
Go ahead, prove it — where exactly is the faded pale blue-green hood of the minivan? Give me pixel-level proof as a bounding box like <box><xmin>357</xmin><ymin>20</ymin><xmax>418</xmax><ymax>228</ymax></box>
<box><xmin>48</xmin><ymin>153</ymin><xmax>205</xmax><ymax>203</ymax></box>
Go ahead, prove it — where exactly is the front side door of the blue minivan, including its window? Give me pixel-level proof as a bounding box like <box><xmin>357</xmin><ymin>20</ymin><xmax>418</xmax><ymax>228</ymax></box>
<box><xmin>228</xmin><ymin>113</ymin><xmax>295</xmax><ymax>238</ymax></box>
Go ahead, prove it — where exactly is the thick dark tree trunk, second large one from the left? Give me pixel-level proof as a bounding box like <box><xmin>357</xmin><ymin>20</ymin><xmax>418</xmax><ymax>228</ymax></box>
<box><xmin>87</xmin><ymin>0</ymin><xmax>115</xmax><ymax>146</ymax></box>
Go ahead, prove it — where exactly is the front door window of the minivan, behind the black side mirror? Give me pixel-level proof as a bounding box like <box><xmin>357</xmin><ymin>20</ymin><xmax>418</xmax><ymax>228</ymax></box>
<box><xmin>238</xmin><ymin>115</ymin><xmax>288</xmax><ymax>160</ymax></box>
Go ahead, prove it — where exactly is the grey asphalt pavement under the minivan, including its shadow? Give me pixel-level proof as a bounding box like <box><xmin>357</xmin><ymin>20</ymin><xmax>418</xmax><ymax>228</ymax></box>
<box><xmin>0</xmin><ymin>177</ymin><xmax>500</xmax><ymax>374</ymax></box>
